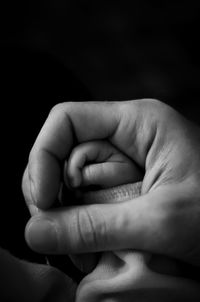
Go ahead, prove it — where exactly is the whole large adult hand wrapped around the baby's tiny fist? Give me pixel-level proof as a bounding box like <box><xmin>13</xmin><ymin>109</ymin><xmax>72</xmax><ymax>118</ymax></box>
<box><xmin>23</xmin><ymin>100</ymin><xmax>200</xmax><ymax>264</ymax></box>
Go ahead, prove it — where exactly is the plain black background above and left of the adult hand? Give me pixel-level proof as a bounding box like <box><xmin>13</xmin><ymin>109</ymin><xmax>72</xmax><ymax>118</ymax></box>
<box><xmin>0</xmin><ymin>0</ymin><xmax>200</xmax><ymax>282</ymax></box>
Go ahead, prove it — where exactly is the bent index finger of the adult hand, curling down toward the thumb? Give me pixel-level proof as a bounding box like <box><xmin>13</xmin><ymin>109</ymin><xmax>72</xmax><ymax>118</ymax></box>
<box><xmin>22</xmin><ymin>102</ymin><xmax>119</xmax><ymax>209</ymax></box>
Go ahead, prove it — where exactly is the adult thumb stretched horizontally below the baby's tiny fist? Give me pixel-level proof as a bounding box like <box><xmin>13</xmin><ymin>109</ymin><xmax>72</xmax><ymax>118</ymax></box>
<box><xmin>25</xmin><ymin>186</ymin><xmax>162</xmax><ymax>254</ymax></box>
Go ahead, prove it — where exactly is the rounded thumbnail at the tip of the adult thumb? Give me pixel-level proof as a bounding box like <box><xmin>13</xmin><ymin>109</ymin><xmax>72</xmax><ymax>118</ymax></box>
<box><xmin>25</xmin><ymin>218</ymin><xmax>58</xmax><ymax>254</ymax></box>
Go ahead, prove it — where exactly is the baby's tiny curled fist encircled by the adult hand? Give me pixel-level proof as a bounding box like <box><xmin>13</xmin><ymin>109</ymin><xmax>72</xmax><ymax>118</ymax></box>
<box><xmin>65</xmin><ymin>140</ymin><xmax>142</xmax><ymax>188</ymax></box>
